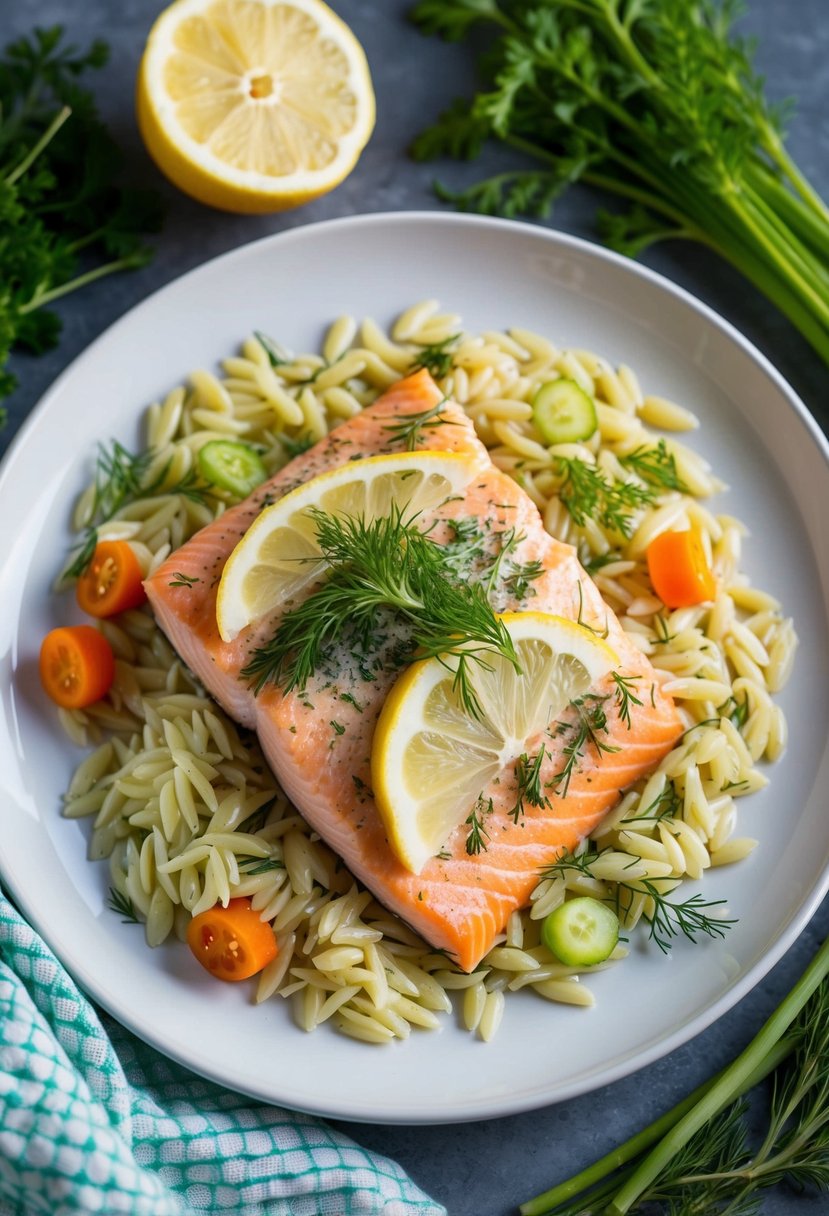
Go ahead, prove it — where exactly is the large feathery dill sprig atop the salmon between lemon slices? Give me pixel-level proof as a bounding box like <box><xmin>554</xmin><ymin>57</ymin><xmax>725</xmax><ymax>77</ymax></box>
<box><xmin>242</xmin><ymin>507</ymin><xmax>518</xmax><ymax>716</ymax></box>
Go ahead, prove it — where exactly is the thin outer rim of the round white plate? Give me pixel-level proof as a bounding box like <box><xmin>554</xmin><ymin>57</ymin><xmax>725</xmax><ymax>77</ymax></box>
<box><xmin>0</xmin><ymin>210</ymin><xmax>829</xmax><ymax>1125</ymax></box>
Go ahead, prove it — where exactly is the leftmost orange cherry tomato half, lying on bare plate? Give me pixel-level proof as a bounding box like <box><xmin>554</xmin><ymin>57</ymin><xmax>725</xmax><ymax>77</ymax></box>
<box><xmin>40</xmin><ymin>625</ymin><xmax>115</xmax><ymax>709</ymax></box>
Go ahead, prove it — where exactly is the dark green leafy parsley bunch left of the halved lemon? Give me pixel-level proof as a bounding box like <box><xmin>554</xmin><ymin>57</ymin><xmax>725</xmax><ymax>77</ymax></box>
<box><xmin>0</xmin><ymin>27</ymin><xmax>160</xmax><ymax>418</ymax></box>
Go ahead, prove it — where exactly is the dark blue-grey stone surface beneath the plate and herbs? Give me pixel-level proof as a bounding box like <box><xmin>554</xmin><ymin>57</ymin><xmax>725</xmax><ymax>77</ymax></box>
<box><xmin>0</xmin><ymin>0</ymin><xmax>829</xmax><ymax>1216</ymax></box>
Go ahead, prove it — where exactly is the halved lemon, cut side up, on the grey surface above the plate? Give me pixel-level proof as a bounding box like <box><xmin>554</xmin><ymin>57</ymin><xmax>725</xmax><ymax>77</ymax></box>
<box><xmin>136</xmin><ymin>0</ymin><xmax>374</xmax><ymax>212</ymax></box>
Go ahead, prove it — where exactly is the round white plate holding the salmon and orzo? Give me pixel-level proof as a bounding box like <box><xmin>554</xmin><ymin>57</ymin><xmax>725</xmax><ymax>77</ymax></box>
<box><xmin>0</xmin><ymin>214</ymin><xmax>829</xmax><ymax>1122</ymax></box>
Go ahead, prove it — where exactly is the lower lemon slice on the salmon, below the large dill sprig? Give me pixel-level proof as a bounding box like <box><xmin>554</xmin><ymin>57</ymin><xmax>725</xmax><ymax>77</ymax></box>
<box><xmin>371</xmin><ymin>612</ymin><xmax>617</xmax><ymax>874</ymax></box>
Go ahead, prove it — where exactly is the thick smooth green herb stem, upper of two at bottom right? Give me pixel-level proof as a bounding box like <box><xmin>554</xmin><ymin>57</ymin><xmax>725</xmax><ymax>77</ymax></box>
<box><xmin>607</xmin><ymin>939</ymin><xmax>829</xmax><ymax>1216</ymax></box>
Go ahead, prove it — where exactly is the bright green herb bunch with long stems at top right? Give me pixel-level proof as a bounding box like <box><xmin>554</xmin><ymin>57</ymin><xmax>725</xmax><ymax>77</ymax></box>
<box><xmin>412</xmin><ymin>0</ymin><xmax>829</xmax><ymax>362</ymax></box>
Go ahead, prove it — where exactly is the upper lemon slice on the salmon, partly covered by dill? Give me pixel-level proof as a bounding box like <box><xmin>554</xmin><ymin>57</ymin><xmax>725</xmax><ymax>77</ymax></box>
<box><xmin>216</xmin><ymin>451</ymin><xmax>478</xmax><ymax>642</ymax></box>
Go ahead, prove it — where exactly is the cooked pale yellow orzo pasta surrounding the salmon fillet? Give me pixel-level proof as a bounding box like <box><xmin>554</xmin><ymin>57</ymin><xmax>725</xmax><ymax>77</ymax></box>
<box><xmin>60</xmin><ymin>300</ymin><xmax>796</xmax><ymax>1042</ymax></box>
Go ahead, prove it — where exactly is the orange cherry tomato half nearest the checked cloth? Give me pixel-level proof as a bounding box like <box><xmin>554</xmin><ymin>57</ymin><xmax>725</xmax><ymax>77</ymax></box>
<box><xmin>187</xmin><ymin>899</ymin><xmax>277</xmax><ymax>980</ymax></box>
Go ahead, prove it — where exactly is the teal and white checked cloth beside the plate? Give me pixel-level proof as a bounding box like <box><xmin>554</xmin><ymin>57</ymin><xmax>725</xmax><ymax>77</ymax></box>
<box><xmin>0</xmin><ymin>893</ymin><xmax>445</xmax><ymax>1216</ymax></box>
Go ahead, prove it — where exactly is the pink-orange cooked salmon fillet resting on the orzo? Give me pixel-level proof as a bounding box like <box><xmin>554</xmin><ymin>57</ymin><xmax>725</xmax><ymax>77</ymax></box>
<box><xmin>146</xmin><ymin>371</ymin><xmax>682</xmax><ymax>970</ymax></box>
